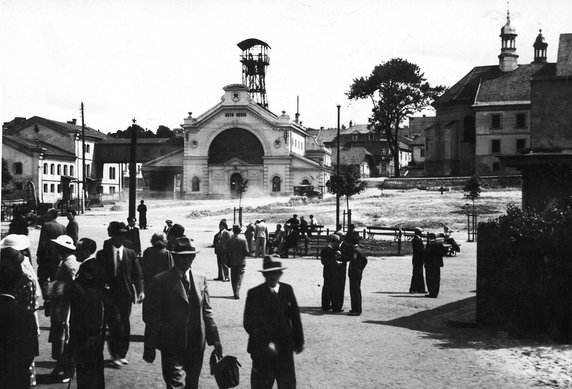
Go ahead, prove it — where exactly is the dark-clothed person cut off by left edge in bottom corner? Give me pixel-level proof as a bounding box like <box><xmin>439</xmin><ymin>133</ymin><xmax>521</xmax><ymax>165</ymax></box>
<box><xmin>0</xmin><ymin>247</ymin><xmax>39</xmax><ymax>389</ymax></box>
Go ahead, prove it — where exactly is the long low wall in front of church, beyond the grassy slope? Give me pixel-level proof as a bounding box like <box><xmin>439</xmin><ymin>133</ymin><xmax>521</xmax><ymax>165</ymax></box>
<box><xmin>366</xmin><ymin>175</ymin><xmax>522</xmax><ymax>190</ymax></box>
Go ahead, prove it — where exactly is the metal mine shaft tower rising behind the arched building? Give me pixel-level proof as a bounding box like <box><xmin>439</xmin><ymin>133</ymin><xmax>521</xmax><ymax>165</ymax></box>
<box><xmin>237</xmin><ymin>38</ymin><xmax>270</xmax><ymax>108</ymax></box>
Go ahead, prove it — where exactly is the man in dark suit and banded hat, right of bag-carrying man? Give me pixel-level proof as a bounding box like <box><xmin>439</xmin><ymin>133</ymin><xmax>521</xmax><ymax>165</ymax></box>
<box><xmin>244</xmin><ymin>256</ymin><xmax>304</xmax><ymax>389</ymax></box>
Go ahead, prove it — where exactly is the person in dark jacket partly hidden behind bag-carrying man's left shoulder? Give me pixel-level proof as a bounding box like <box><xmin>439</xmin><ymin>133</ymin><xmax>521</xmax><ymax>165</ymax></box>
<box><xmin>141</xmin><ymin>232</ymin><xmax>173</xmax><ymax>292</ymax></box>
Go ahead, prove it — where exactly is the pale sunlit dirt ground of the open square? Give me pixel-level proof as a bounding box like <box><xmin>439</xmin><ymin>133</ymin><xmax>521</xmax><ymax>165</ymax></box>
<box><xmin>13</xmin><ymin>190</ymin><xmax>572</xmax><ymax>389</ymax></box>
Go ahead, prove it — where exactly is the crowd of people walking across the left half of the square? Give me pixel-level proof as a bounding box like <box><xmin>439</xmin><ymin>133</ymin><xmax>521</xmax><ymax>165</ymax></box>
<box><xmin>0</xmin><ymin>209</ymin><xmax>304</xmax><ymax>389</ymax></box>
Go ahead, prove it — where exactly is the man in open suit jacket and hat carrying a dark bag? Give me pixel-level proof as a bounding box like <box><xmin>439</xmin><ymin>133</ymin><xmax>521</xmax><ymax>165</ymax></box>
<box><xmin>143</xmin><ymin>237</ymin><xmax>222</xmax><ymax>389</ymax></box>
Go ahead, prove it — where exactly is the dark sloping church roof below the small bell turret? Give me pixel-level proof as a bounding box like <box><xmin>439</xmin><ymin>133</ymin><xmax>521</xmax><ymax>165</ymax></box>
<box><xmin>433</xmin><ymin>63</ymin><xmax>556</xmax><ymax>107</ymax></box>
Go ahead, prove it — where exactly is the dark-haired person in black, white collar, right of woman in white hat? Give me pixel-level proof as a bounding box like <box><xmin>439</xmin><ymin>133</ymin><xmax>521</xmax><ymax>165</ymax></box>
<box><xmin>70</xmin><ymin>238</ymin><xmax>105</xmax><ymax>389</ymax></box>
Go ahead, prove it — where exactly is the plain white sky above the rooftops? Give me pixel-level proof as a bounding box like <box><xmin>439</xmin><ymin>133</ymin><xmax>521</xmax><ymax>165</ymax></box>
<box><xmin>0</xmin><ymin>0</ymin><xmax>572</xmax><ymax>133</ymax></box>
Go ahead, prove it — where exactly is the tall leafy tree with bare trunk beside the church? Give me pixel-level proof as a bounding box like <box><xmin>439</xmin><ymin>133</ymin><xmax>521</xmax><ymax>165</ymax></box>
<box><xmin>346</xmin><ymin>58</ymin><xmax>445</xmax><ymax>177</ymax></box>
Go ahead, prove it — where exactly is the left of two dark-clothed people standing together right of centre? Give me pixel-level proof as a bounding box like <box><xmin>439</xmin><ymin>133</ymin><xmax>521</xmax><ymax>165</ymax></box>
<box><xmin>320</xmin><ymin>234</ymin><xmax>346</xmax><ymax>312</ymax></box>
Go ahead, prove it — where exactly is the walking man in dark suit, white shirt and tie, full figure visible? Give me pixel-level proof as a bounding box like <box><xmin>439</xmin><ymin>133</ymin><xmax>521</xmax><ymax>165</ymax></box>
<box><xmin>96</xmin><ymin>222</ymin><xmax>145</xmax><ymax>367</ymax></box>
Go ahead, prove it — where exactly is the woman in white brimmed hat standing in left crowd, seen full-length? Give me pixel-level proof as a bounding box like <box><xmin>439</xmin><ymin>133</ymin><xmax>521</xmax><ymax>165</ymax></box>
<box><xmin>48</xmin><ymin>235</ymin><xmax>80</xmax><ymax>382</ymax></box>
